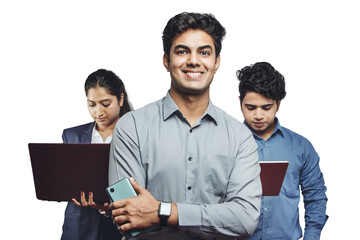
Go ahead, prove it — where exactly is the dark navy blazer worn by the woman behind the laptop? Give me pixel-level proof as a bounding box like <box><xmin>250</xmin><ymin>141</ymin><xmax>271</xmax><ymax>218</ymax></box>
<box><xmin>61</xmin><ymin>122</ymin><xmax>122</xmax><ymax>240</ymax></box>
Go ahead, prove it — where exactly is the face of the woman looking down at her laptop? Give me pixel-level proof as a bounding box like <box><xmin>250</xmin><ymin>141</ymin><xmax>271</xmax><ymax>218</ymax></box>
<box><xmin>87</xmin><ymin>87</ymin><xmax>124</xmax><ymax>130</ymax></box>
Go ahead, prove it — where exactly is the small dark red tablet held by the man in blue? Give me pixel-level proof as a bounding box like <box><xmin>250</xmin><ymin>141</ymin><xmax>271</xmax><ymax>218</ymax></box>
<box><xmin>259</xmin><ymin>161</ymin><xmax>289</xmax><ymax>196</ymax></box>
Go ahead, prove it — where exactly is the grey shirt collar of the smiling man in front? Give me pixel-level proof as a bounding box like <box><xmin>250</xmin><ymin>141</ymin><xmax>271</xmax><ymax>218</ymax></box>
<box><xmin>163</xmin><ymin>91</ymin><xmax>218</xmax><ymax>125</ymax></box>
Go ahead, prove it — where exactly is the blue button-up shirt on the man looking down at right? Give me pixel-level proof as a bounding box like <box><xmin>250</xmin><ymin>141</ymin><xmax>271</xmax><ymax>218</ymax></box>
<box><xmin>245</xmin><ymin>118</ymin><xmax>328</xmax><ymax>240</ymax></box>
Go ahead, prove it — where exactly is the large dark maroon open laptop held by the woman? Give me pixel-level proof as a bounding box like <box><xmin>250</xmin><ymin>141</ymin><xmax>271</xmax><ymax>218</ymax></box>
<box><xmin>29</xmin><ymin>143</ymin><xmax>110</xmax><ymax>203</ymax></box>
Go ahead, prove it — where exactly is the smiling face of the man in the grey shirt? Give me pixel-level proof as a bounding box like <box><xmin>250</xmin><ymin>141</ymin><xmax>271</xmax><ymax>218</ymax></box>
<box><xmin>163</xmin><ymin>29</ymin><xmax>220</xmax><ymax>95</ymax></box>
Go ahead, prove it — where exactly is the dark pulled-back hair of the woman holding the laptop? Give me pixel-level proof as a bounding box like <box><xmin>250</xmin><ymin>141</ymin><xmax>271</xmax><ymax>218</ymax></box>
<box><xmin>85</xmin><ymin>69</ymin><xmax>133</xmax><ymax>117</ymax></box>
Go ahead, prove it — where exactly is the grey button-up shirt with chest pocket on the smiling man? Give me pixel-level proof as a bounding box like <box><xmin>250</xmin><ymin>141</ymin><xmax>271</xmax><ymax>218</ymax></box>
<box><xmin>109</xmin><ymin>93</ymin><xmax>262</xmax><ymax>239</ymax></box>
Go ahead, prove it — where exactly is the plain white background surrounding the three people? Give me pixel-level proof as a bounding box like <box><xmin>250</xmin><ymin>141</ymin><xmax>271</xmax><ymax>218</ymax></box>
<box><xmin>0</xmin><ymin>0</ymin><xmax>360</xmax><ymax>239</ymax></box>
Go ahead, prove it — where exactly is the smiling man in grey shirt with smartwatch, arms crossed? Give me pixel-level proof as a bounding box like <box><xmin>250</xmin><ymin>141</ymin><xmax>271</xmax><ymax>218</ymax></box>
<box><xmin>109</xmin><ymin>13</ymin><xmax>262</xmax><ymax>239</ymax></box>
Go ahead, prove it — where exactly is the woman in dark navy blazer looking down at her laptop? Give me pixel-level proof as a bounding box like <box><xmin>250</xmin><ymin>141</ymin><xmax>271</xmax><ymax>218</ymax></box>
<box><xmin>61</xmin><ymin>69</ymin><xmax>132</xmax><ymax>240</ymax></box>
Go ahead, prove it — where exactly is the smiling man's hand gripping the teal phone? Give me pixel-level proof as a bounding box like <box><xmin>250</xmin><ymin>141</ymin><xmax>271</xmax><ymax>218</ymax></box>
<box><xmin>110</xmin><ymin>177</ymin><xmax>160</xmax><ymax>232</ymax></box>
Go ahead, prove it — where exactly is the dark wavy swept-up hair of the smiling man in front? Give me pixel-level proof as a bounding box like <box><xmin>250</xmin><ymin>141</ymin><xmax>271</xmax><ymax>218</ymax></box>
<box><xmin>162</xmin><ymin>12</ymin><xmax>226</xmax><ymax>57</ymax></box>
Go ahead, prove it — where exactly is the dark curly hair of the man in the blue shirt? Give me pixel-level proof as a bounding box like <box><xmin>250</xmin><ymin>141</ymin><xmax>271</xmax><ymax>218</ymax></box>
<box><xmin>236</xmin><ymin>62</ymin><xmax>286</xmax><ymax>102</ymax></box>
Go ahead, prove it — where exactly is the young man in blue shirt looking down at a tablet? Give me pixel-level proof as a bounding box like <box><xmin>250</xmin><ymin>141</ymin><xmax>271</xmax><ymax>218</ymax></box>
<box><xmin>237</xmin><ymin>62</ymin><xmax>328</xmax><ymax>240</ymax></box>
